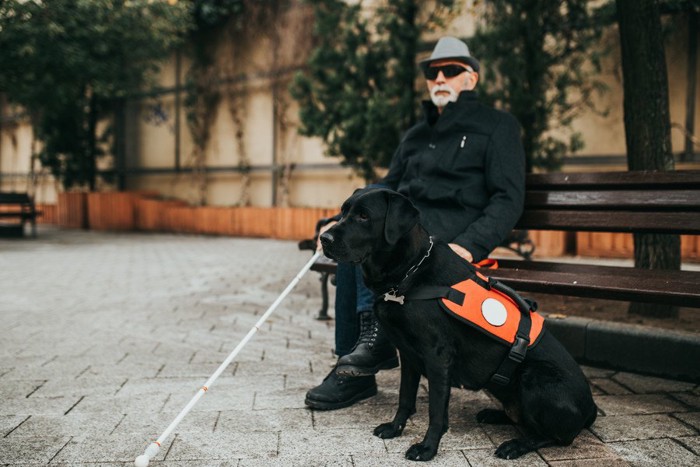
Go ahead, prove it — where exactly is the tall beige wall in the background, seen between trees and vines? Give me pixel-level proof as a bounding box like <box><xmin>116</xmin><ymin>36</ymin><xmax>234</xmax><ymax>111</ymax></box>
<box><xmin>0</xmin><ymin>1</ymin><xmax>700</xmax><ymax>208</ymax></box>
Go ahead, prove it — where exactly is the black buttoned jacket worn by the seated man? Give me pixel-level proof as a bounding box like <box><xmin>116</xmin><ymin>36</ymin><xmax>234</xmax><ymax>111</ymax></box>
<box><xmin>381</xmin><ymin>91</ymin><xmax>525</xmax><ymax>261</ymax></box>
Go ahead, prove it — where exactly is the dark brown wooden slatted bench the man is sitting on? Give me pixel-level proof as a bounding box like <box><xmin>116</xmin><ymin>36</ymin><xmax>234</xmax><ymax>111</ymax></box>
<box><xmin>304</xmin><ymin>171</ymin><xmax>700</xmax><ymax>316</ymax></box>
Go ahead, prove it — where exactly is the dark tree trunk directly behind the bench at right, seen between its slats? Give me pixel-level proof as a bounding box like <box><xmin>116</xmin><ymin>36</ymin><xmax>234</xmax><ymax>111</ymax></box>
<box><xmin>616</xmin><ymin>0</ymin><xmax>680</xmax><ymax>317</ymax></box>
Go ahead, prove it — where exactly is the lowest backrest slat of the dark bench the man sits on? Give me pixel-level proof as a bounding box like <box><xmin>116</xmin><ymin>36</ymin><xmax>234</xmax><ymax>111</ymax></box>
<box><xmin>516</xmin><ymin>209</ymin><xmax>700</xmax><ymax>234</ymax></box>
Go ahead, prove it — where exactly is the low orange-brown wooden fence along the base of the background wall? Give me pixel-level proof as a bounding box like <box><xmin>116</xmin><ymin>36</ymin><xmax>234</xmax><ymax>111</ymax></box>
<box><xmin>52</xmin><ymin>192</ymin><xmax>700</xmax><ymax>260</ymax></box>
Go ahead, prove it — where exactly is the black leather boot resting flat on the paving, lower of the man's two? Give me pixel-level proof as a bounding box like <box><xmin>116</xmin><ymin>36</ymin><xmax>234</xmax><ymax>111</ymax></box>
<box><xmin>304</xmin><ymin>368</ymin><xmax>377</xmax><ymax>410</ymax></box>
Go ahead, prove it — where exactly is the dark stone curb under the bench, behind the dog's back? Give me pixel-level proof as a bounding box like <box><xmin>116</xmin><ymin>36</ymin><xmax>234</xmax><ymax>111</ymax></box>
<box><xmin>545</xmin><ymin>316</ymin><xmax>700</xmax><ymax>383</ymax></box>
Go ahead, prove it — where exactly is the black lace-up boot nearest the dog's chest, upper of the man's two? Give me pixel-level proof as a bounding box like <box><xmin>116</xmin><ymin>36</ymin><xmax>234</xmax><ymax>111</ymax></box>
<box><xmin>337</xmin><ymin>311</ymin><xmax>399</xmax><ymax>377</ymax></box>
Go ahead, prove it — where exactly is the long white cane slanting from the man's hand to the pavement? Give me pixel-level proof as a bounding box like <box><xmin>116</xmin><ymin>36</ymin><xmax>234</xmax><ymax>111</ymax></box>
<box><xmin>134</xmin><ymin>251</ymin><xmax>321</xmax><ymax>467</ymax></box>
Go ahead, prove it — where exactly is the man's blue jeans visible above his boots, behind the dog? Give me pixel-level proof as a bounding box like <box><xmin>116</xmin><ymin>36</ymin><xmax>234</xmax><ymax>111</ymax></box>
<box><xmin>335</xmin><ymin>263</ymin><xmax>374</xmax><ymax>357</ymax></box>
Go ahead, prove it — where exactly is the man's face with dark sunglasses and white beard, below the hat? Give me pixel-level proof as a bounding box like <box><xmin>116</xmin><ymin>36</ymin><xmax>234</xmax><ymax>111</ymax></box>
<box><xmin>426</xmin><ymin>60</ymin><xmax>479</xmax><ymax>111</ymax></box>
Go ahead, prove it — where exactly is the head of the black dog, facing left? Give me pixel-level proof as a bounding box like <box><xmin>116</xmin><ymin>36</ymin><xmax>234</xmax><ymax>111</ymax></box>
<box><xmin>321</xmin><ymin>188</ymin><xmax>420</xmax><ymax>263</ymax></box>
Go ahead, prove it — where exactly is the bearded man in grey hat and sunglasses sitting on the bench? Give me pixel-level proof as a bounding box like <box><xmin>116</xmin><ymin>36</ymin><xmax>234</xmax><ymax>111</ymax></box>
<box><xmin>305</xmin><ymin>37</ymin><xmax>525</xmax><ymax>410</ymax></box>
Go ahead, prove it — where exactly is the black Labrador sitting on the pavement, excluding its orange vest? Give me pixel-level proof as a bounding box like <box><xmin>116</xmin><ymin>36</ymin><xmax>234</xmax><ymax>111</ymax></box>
<box><xmin>321</xmin><ymin>189</ymin><xmax>597</xmax><ymax>460</ymax></box>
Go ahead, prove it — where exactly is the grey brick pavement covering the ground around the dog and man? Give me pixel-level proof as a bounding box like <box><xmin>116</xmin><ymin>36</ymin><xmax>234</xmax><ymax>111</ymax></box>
<box><xmin>0</xmin><ymin>227</ymin><xmax>700</xmax><ymax>467</ymax></box>
